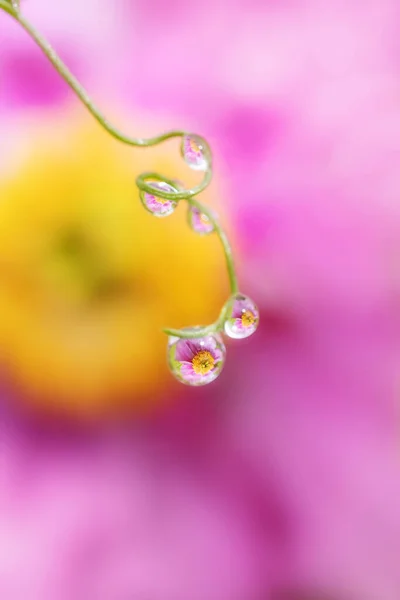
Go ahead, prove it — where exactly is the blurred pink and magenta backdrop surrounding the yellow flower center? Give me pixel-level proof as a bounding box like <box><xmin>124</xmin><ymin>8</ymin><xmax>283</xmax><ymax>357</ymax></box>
<box><xmin>0</xmin><ymin>0</ymin><xmax>400</xmax><ymax>600</ymax></box>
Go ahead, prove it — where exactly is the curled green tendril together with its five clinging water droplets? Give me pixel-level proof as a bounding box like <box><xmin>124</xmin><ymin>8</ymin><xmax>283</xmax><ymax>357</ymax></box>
<box><xmin>0</xmin><ymin>0</ymin><xmax>259</xmax><ymax>386</ymax></box>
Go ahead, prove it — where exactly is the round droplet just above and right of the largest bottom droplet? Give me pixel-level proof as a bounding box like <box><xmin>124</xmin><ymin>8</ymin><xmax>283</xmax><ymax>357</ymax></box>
<box><xmin>224</xmin><ymin>294</ymin><xmax>260</xmax><ymax>340</ymax></box>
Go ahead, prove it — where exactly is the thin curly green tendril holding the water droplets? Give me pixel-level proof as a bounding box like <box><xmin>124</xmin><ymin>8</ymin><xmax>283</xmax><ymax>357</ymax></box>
<box><xmin>0</xmin><ymin>0</ymin><xmax>245</xmax><ymax>346</ymax></box>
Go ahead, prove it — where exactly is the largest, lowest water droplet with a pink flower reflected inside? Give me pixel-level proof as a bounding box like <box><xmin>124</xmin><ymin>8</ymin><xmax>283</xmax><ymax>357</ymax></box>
<box><xmin>168</xmin><ymin>333</ymin><xmax>226</xmax><ymax>386</ymax></box>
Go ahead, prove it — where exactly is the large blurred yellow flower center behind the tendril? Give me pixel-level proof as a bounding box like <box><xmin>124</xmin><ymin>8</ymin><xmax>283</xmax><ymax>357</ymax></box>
<box><xmin>0</xmin><ymin>118</ymin><xmax>227</xmax><ymax>418</ymax></box>
